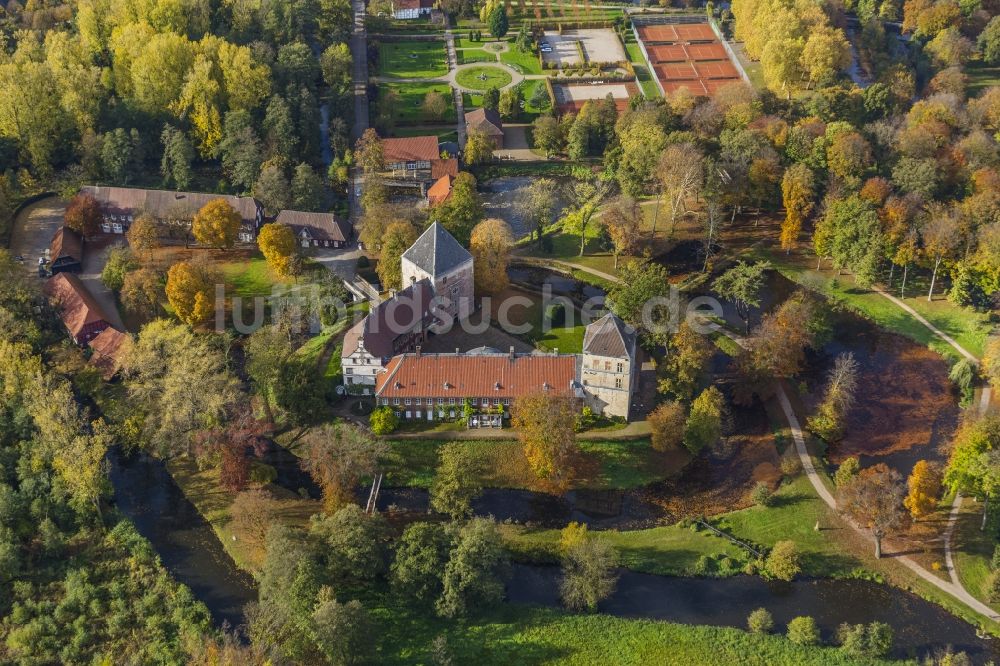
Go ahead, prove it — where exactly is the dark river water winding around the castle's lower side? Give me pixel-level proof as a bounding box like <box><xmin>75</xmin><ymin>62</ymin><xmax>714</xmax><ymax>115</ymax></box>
<box><xmin>105</xmin><ymin>446</ymin><xmax>1000</xmax><ymax>662</ymax></box>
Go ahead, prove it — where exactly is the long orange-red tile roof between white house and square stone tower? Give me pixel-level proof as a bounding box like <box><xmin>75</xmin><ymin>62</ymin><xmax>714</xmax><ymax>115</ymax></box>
<box><xmin>375</xmin><ymin>354</ymin><xmax>577</xmax><ymax>398</ymax></box>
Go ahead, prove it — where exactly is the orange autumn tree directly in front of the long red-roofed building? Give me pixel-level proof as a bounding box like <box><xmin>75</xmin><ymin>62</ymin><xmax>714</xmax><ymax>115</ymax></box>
<box><xmin>511</xmin><ymin>393</ymin><xmax>580</xmax><ymax>488</ymax></box>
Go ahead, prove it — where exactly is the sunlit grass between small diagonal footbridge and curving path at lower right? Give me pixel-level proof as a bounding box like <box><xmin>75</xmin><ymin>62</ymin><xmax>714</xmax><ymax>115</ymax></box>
<box><xmin>709</xmin><ymin>475</ymin><xmax>861</xmax><ymax>577</ymax></box>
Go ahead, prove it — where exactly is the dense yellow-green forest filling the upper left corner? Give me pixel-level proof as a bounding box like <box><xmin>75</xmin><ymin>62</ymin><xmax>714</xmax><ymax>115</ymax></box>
<box><xmin>0</xmin><ymin>0</ymin><xmax>351</xmax><ymax>237</ymax></box>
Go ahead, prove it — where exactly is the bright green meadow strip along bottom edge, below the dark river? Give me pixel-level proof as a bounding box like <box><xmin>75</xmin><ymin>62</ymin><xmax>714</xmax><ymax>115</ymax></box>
<box><xmin>372</xmin><ymin>593</ymin><xmax>889</xmax><ymax>666</ymax></box>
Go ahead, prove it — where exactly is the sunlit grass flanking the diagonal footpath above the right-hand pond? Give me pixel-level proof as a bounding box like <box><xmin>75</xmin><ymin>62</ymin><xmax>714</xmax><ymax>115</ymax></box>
<box><xmin>759</xmin><ymin>250</ymin><xmax>991</xmax><ymax>360</ymax></box>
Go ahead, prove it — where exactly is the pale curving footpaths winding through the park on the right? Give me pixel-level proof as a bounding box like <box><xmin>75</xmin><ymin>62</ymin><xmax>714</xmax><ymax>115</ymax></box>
<box><xmin>548</xmin><ymin>254</ymin><xmax>1000</xmax><ymax>622</ymax></box>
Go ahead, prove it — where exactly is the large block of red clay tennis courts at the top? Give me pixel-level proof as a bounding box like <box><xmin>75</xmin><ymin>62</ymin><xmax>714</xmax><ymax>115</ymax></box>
<box><xmin>636</xmin><ymin>17</ymin><xmax>740</xmax><ymax>95</ymax></box>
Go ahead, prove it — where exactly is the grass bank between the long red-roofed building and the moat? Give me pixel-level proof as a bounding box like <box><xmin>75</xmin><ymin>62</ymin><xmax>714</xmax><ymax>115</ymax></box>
<box><xmin>378</xmin><ymin>439</ymin><xmax>687</xmax><ymax>491</ymax></box>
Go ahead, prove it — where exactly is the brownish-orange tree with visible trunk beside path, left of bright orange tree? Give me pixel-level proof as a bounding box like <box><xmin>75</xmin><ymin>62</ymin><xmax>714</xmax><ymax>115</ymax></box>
<box><xmin>837</xmin><ymin>463</ymin><xmax>906</xmax><ymax>559</ymax></box>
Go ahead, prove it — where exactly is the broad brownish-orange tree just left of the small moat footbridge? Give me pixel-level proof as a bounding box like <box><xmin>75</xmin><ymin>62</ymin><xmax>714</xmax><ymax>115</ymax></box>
<box><xmin>302</xmin><ymin>423</ymin><xmax>388</xmax><ymax>513</ymax></box>
